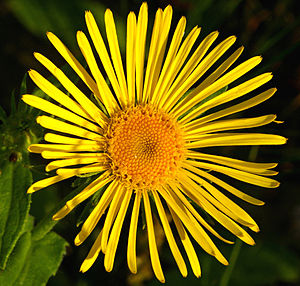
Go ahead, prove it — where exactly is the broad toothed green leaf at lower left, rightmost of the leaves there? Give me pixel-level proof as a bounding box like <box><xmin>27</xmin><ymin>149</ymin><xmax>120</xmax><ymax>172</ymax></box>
<box><xmin>14</xmin><ymin>232</ymin><xmax>67</xmax><ymax>286</ymax></box>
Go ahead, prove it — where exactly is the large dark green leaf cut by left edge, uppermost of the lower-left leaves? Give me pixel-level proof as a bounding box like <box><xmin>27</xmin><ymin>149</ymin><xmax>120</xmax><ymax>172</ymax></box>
<box><xmin>0</xmin><ymin>162</ymin><xmax>32</xmax><ymax>269</ymax></box>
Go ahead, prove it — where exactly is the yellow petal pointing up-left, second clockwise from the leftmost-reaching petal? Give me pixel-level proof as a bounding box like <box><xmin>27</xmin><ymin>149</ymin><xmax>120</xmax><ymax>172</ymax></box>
<box><xmin>34</xmin><ymin>53</ymin><xmax>107</xmax><ymax>126</ymax></box>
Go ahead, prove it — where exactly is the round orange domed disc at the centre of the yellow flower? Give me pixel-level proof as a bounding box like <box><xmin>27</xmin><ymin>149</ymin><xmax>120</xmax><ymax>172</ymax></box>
<box><xmin>106</xmin><ymin>105</ymin><xmax>184</xmax><ymax>189</ymax></box>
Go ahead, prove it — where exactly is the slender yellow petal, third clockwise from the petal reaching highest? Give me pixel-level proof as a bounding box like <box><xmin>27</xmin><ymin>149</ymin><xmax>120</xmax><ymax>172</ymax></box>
<box><xmin>150</xmin><ymin>17</ymin><xmax>186</xmax><ymax>104</ymax></box>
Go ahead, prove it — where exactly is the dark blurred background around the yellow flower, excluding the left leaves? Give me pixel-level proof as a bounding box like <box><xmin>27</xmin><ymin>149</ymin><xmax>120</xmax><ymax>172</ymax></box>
<box><xmin>0</xmin><ymin>0</ymin><xmax>300</xmax><ymax>286</ymax></box>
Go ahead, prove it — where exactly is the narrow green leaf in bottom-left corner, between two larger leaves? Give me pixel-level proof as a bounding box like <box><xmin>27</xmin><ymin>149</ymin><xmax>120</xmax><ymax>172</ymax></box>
<box><xmin>0</xmin><ymin>232</ymin><xmax>31</xmax><ymax>286</ymax></box>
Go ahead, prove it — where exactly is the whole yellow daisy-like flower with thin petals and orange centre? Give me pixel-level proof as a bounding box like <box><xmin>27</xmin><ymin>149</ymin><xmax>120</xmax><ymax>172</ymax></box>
<box><xmin>23</xmin><ymin>3</ymin><xmax>286</xmax><ymax>282</ymax></box>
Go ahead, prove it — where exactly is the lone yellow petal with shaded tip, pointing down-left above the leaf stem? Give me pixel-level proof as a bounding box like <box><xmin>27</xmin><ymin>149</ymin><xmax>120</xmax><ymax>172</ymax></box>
<box><xmin>52</xmin><ymin>172</ymin><xmax>114</xmax><ymax>220</ymax></box>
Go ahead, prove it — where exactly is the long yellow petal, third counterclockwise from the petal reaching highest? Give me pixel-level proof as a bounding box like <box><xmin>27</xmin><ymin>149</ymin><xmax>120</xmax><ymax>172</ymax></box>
<box><xmin>85</xmin><ymin>11</ymin><xmax>124</xmax><ymax>106</ymax></box>
